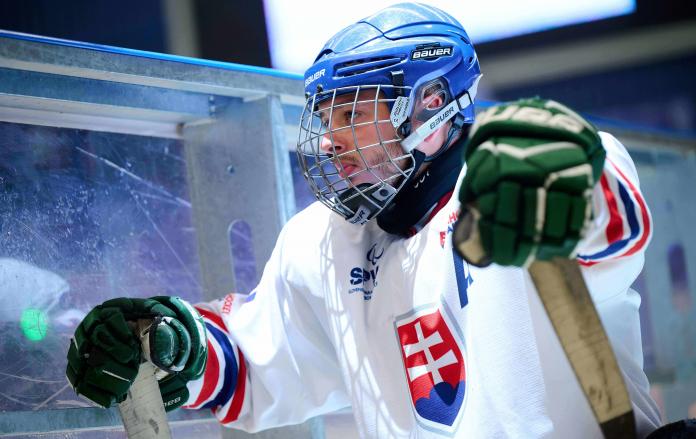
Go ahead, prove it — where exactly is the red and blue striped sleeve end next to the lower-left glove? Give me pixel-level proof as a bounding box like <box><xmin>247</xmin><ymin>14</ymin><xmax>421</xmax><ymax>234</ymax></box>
<box><xmin>185</xmin><ymin>294</ymin><xmax>247</xmax><ymax>425</ymax></box>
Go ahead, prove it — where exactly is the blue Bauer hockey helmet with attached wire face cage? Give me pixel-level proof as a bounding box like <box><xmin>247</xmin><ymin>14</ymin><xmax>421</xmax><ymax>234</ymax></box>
<box><xmin>297</xmin><ymin>3</ymin><xmax>481</xmax><ymax>223</ymax></box>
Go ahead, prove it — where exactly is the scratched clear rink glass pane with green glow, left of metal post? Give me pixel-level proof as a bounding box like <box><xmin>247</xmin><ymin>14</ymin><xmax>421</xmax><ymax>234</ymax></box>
<box><xmin>0</xmin><ymin>123</ymin><xmax>202</xmax><ymax>411</ymax></box>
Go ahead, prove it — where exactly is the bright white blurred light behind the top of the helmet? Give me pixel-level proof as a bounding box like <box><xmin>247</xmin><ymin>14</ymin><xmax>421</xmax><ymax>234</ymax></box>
<box><xmin>264</xmin><ymin>0</ymin><xmax>636</xmax><ymax>73</ymax></box>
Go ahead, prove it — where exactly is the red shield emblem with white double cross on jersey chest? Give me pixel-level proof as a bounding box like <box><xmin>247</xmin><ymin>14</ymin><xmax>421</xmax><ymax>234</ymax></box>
<box><xmin>395</xmin><ymin>304</ymin><xmax>466</xmax><ymax>433</ymax></box>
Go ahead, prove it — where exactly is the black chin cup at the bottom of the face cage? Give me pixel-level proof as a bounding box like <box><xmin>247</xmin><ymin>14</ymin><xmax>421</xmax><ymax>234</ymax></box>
<box><xmin>335</xmin><ymin>183</ymin><xmax>396</xmax><ymax>224</ymax></box>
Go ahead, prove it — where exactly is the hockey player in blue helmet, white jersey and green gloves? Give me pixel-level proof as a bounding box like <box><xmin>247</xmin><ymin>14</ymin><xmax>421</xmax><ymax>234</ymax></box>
<box><xmin>67</xmin><ymin>4</ymin><xmax>659</xmax><ymax>439</ymax></box>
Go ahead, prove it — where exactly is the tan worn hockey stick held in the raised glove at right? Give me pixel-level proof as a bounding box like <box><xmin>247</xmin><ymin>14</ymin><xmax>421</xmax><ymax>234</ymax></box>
<box><xmin>453</xmin><ymin>212</ymin><xmax>636</xmax><ymax>439</ymax></box>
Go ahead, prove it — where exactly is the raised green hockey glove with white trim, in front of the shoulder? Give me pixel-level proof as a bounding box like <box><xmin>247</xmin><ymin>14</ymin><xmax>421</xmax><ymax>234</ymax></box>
<box><xmin>454</xmin><ymin>98</ymin><xmax>605</xmax><ymax>266</ymax></box>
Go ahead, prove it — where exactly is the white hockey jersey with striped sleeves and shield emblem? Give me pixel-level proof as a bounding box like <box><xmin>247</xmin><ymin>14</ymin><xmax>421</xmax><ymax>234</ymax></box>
<box><xmin>182</xmin><ymin>133</ymin><xmax>659</xmax><ymax>439</ymax></box>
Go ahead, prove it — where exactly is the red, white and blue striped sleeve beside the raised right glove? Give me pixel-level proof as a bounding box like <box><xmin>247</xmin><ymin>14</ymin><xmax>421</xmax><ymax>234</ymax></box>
<box><xmin>577</xmin><ymin>133</ymin><xmax>652</xmax><ymax>267</ymax></box>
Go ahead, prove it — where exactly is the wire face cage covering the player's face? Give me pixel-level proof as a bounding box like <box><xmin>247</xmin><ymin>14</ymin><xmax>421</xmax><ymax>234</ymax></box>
<box><xmin>297</xmin><ymin>85</ymin><xmax>415</xmax><ymax>223</ymax></box>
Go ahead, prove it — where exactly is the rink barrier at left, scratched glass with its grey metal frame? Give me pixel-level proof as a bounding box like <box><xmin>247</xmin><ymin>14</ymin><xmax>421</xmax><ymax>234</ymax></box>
<box><xmin>0</xmin><ymin>31</ymin><xmax>304</xmax><ymax>439</ymax></box>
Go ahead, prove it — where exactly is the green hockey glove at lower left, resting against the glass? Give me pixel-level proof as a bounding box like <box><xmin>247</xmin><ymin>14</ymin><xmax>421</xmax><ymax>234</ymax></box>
<box><xmin>66</xmin><ymin>296</ymin><xmax>207</xmax><ymax>411</ymax></box>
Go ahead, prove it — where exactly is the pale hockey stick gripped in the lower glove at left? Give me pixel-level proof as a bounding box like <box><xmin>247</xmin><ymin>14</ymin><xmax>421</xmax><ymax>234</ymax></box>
<box><xmin>118</xmin><ymin>319</ymin><xmax>172</xmax><ymax>439</ymax></box>
